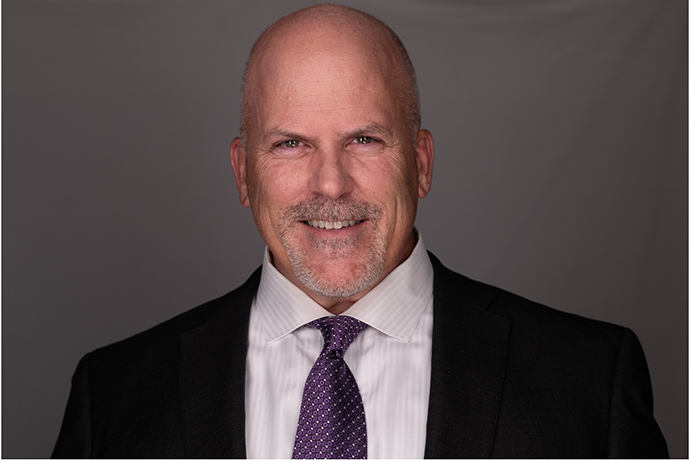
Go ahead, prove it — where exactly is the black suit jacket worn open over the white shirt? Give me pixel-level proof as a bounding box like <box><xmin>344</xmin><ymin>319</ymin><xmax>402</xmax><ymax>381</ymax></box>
<box><xmin>53</xmin><ymin>255</ymin><xmax>668</xmax><ymax>458</ymax></box>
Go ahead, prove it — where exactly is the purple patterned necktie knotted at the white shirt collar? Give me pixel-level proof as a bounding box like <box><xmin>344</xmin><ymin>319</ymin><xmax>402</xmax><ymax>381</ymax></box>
<box><xmin>292</xmin><ymin>316</ymin><xmax>367</xmax><ymax>458</ymax></box>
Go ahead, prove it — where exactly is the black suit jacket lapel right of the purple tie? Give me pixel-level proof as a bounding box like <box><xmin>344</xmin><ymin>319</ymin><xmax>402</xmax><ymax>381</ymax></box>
<box><xmin>424</xmin><ymin>254</ymin><xmax>509</xmax><ymax>458</ymax></box>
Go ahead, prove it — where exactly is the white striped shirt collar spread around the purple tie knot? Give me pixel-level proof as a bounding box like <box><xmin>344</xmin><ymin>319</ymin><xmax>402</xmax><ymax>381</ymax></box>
<box><xmin>255</xmin><ymin>233</ymin><xmax>434</xmax><ymax>344</ymax></box>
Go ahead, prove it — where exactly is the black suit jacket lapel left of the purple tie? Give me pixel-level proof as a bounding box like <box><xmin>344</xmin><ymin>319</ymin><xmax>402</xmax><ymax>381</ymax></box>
<box><xmin>180</xmin><ymin>269</ymin><xmax>261</xmax><ymax>458</ymax></box>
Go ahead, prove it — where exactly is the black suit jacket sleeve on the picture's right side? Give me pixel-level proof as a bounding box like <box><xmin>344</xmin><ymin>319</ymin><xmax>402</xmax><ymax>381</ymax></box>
<box><xmin>608</xmin><ymin>328</ymin><xmax>668</xmax><ymax>458</ymax></box>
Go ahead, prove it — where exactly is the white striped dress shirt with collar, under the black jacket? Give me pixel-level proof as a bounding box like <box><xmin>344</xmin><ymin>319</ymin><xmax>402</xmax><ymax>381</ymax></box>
<box><xmin>245</xmin><ymin>236</ymin><xmax>433</xmax><ymax>458</ymax></box>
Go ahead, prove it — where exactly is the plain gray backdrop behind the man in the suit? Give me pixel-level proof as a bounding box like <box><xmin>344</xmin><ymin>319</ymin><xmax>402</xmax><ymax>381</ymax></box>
<box><xmin>2</xmin><ymin>0</ymin><xmax>688</xmax><ymax>457</ymax></box>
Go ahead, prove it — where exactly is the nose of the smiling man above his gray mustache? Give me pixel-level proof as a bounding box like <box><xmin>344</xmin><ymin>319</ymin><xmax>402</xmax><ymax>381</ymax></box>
<box><xmin>309</xmin><ymin>148</ymin><xmax>355</xmax><ymax>200</ymax></box>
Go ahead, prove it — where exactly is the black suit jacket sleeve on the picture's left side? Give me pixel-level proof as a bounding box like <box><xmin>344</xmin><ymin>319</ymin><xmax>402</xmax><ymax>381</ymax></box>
<box><xmin>52</xmin><ymin>355</ymin><xmax>91</xmax><ymax>458</ymax></box>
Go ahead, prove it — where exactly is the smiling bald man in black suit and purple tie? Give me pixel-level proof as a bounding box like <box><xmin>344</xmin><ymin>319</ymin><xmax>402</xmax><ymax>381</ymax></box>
<box><xmin>53</xmin><ymin>5</ymin><xmax>668</xmax><ymax>458</ymax></box>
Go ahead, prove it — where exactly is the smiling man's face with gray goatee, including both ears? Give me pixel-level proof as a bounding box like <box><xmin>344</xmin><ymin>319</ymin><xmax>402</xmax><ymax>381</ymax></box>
<box><xmin>232</xmin><ymin>31</ymin><xmax>433</xmax><ymax>308</ymax></box>
